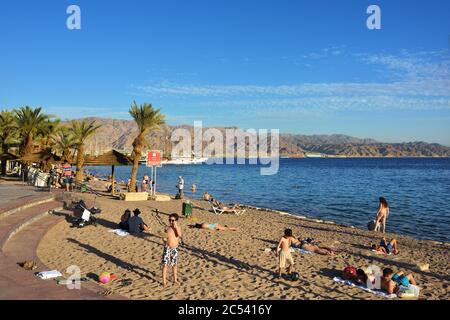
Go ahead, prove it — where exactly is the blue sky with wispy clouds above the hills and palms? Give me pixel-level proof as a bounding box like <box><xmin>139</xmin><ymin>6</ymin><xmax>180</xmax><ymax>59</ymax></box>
<box><xmin>0</xmin><ymin>0</ymin><xmax>450</xmax><ymax>145</ymax></box>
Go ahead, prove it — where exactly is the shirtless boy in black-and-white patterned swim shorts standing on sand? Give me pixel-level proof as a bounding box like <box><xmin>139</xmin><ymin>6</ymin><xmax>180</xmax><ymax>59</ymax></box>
<box><xmin>161</xmin><ymin>213</ymin><xmax>182</xmax><ymax>287</ymax></box>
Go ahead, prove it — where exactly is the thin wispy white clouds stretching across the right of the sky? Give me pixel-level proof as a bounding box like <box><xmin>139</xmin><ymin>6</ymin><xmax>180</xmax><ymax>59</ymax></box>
<box><xmin>131</xmin><ymin>47</ymin><xmax>450</xmax><ymax>111</ymax></box>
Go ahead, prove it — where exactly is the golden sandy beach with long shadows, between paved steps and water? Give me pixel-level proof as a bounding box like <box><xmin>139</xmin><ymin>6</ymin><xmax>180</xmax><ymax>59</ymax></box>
<box><xmin>38</xmin><ymin>189</ymin><xmax>450</xmax><ymax>300</ymax></box>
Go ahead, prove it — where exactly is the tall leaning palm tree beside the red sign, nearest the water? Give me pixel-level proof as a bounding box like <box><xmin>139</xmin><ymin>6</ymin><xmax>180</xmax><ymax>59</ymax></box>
<box><xmin>129</xmin><ymin>101</ymin><xmax>165</xmax><ymax>192</ymax></box>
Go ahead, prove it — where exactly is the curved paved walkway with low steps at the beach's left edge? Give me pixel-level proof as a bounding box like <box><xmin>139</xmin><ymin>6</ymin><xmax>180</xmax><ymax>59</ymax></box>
<box><xmin>0</xmin><ymin>183</ymin><xmax>123</xmax><ymax>300</ymax></box>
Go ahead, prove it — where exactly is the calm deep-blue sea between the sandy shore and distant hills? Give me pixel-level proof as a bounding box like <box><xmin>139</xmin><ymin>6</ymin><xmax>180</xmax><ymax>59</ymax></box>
<box><xmin>89</xmin><ymin>158</ymin><xmax>450</xmax><ymax>242</ymax></box>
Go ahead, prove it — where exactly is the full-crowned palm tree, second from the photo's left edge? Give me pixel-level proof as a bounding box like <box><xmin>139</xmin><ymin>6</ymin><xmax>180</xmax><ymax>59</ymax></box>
<box><xmin>14</xmin><ymin>106</ymin><xmax>51</xmax><ymax>157</ymax></box>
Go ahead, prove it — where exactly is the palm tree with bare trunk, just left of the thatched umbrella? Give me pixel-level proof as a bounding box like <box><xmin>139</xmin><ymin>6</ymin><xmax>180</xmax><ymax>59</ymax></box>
<box><xmin>69</xmin><ymin>120</ymin><xmax>101</xmax><ymax>182</ymax></box>
